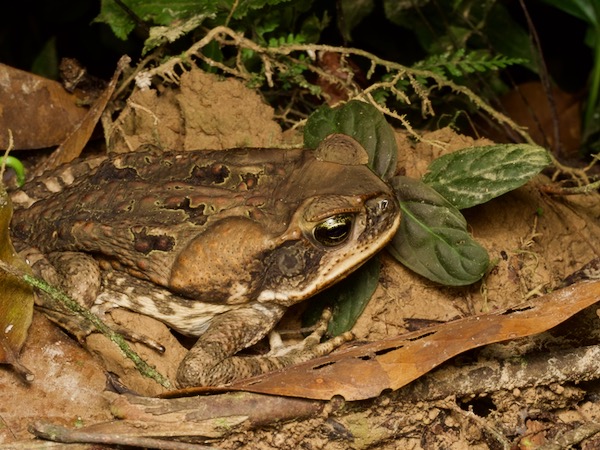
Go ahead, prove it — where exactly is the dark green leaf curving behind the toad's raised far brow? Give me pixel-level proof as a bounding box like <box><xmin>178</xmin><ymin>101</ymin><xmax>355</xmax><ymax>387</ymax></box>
<box><xmin>304</xmin><ymin>100</ymin><xmax>398</xmax><ymax>180</ymax></box>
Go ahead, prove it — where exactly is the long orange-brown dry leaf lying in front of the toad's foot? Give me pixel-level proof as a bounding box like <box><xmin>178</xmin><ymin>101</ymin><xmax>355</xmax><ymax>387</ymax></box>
<box><xmin>230</xmin><ymin>281</ymin><xmax>600</xmax><ymax>400</ymax></box>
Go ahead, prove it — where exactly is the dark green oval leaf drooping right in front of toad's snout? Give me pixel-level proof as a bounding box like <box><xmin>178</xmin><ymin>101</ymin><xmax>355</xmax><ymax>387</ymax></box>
<box><xmin>388</xmin><ymin>176</ymin><xmax>489</xmax><ymax>286</ymax></box>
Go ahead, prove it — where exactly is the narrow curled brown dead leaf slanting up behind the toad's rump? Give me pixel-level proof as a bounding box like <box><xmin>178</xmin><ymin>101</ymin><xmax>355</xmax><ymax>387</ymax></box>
<box><xmin>35</xmin><ymin>56</ymin><xmax>131</xmax><ymax>176</ymax></box>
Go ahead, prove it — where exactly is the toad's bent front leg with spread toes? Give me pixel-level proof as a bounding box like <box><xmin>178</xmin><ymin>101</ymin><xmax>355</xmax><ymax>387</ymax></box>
<box><xmin>177</xmin><ymin>303</ymin><xmax>351</xmax><ymax>387</ymax></box>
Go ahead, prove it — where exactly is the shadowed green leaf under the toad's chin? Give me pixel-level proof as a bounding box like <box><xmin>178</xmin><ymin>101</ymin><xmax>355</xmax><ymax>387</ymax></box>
<box><xmin>303</xmin><ymin>256</ymin><xmax>381</xmax><ymax>336</ymax></box>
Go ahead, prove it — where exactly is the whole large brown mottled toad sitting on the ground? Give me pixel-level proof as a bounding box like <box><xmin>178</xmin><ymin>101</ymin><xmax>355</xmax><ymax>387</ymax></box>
<box><xmin>12</xmin><ymin>135</ymin><xmax>399</xmax><ymax>386</ymax></box>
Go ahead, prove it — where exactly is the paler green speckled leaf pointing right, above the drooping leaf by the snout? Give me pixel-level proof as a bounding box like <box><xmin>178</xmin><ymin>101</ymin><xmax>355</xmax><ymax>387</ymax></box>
<box><xmin>423</xmin><ymin>144</ymin><xmax>551</xmax><ymax>209</ymax></box>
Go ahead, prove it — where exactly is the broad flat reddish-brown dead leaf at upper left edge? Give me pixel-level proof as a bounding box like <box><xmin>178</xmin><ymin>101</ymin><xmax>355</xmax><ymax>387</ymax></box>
<box><xmin>0</xmin><ymin>64</ymin><xmax>87</xmax><ymax>150</ymax></box>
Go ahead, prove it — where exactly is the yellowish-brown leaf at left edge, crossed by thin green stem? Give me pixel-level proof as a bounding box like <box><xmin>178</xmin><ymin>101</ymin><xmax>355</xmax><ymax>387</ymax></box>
<box><xmin>0</xmin><ymin>185</ymin><xmax>34</xmax><ymax>380</ymax></box>
